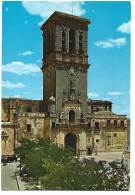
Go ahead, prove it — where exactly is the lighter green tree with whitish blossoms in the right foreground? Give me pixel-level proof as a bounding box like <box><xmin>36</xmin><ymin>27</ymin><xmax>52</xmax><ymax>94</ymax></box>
<box><xmin>41</xmin><ymin>159</ymin><xmax>129</xmax><ymax>191</ymax></box>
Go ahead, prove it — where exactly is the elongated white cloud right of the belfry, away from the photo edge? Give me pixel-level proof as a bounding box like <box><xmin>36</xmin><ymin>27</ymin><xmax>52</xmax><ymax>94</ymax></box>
<box><xmin>95</xmin><ymin>38</ymin><xmax>126</xmax><ymax>48</ymax></box>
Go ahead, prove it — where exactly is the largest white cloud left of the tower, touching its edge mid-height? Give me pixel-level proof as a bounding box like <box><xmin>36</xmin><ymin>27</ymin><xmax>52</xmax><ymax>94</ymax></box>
<box><xmin>2</xmin><ymin>62</ymin><xmax>41</xmax><ymax>75</ymax></box>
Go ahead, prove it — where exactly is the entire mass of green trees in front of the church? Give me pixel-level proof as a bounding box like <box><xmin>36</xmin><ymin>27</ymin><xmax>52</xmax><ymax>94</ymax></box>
<box><xmin>15</xmin><ymin>138</ymin><xmax>129</xmax><ymax>190</ymax></box>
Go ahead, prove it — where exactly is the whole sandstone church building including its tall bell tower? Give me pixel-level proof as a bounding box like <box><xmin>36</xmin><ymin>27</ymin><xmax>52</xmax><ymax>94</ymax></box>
<box><xmin>1</xmin><ymin>12</ymin><xmax>127</xmax><ymax>155</ymax></box>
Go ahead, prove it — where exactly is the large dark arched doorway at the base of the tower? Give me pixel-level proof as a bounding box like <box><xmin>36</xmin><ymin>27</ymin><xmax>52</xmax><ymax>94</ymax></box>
<box><xmin>65</xmin><ymin>133</ymin><xmax>77</xmax><ymax>154</ymax></box>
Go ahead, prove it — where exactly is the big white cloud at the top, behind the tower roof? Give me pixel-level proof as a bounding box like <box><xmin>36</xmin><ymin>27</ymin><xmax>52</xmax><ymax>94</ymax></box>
<box><xmin>22</xmin><ymin>1</ymin><xmax>86</xmax><ymax>25</ymax></box>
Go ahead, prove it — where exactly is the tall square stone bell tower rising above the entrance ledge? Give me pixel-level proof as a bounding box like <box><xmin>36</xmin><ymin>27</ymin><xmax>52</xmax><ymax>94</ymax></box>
<box><xmin>41</xmin><ymin>11</ymin><xmax>90</xmax><ymax>122</ymax></box>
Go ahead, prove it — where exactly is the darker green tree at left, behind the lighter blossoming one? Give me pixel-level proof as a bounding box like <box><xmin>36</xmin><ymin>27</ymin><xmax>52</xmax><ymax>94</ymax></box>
<box><xmin>15</xmin><ymin>137</ymin><xmax>73</xmax><ymax>179</ymax></box>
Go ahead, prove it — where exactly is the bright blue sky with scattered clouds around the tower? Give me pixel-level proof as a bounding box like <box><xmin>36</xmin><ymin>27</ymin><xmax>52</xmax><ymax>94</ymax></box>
<box><xmin>2</xmin><ymin>1</ymin><xmax>131</xmax><ymax>117</ymax></box>
